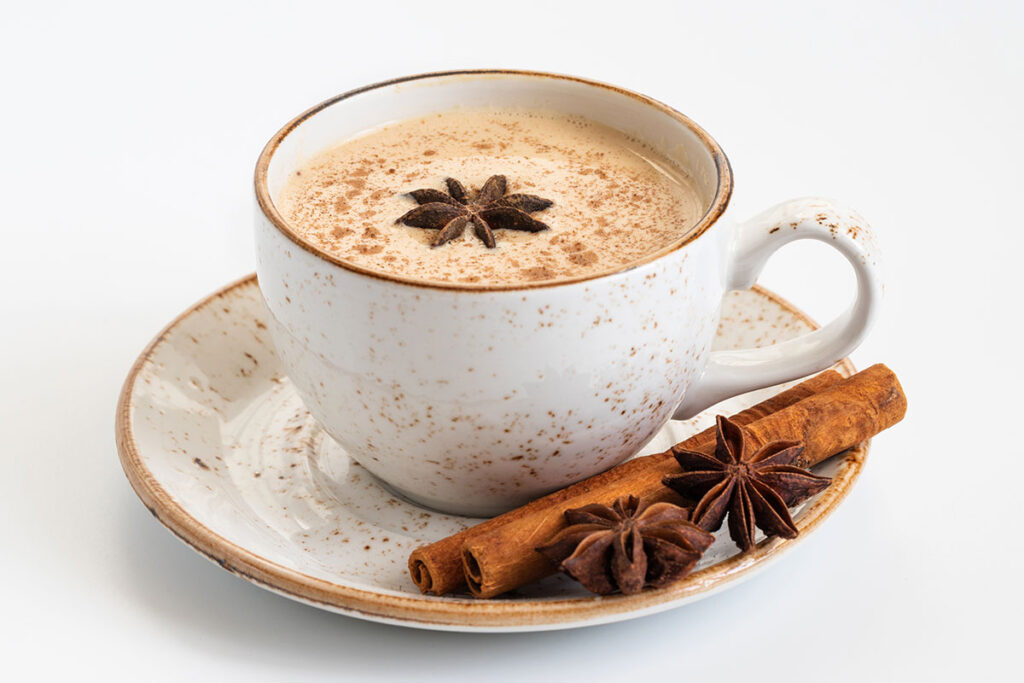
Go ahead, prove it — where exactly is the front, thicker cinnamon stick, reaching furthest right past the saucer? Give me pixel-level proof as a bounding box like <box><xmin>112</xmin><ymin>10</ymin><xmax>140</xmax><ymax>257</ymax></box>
<box><xmin>463</xmin><ymin>365</ymin><xmax>906</xmax><ymax>598</ymax></box>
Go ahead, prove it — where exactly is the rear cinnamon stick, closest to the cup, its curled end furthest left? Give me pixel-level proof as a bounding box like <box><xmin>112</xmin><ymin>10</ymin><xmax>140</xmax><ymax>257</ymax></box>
<box><xmin>409</xmin><ymin>370</ymin><xmax>843</xmax><ymax>595</ymax></box>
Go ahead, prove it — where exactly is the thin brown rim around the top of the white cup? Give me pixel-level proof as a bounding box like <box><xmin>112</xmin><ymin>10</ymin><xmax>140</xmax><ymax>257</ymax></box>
<box><xmin>255</xmin><ymin>69</ymin><xmax>732</xmax><ymax>292</ymax></box>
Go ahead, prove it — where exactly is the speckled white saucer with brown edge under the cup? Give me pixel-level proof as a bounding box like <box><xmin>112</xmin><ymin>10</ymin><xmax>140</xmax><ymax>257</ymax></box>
<box><xmin>117</xmin><ymin>276</ymin><xmax>867</xmax><ymax>631</ymax></box>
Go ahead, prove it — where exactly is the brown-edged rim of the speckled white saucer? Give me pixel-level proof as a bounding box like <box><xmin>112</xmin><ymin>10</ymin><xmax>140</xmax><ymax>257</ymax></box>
<box><xmin>115</xmin><ymin>273</ymin><xmax>870</xmax><ymax>631</ymax></box>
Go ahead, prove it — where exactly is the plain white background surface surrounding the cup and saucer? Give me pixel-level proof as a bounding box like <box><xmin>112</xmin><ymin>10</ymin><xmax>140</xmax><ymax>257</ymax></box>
<box><xmin>0</xmin><ymin>0</ymin><xmax>1024</xmax><ymax>682</ymax></box>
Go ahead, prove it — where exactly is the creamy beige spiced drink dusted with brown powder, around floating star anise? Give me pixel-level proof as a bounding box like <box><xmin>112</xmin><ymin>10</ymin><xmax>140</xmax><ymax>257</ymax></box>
<box><xmin>278</xmin><ymin>109</ymin><xmax>703</xmax><ymax>286</ymax></box>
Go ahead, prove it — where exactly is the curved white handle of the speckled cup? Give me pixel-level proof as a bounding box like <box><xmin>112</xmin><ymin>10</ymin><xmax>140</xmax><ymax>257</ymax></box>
<box><xmin>673</xmin><ymin>198</ymin><xmax>884</xmax><ymax>420</ymax></box>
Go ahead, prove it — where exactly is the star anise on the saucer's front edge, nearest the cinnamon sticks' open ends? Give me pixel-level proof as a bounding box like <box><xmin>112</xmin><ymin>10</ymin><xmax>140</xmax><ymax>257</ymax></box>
<box><xmin>537</xmin><ymin>496</ymin><xmax>715</xmax><ymax>595</ymax></box>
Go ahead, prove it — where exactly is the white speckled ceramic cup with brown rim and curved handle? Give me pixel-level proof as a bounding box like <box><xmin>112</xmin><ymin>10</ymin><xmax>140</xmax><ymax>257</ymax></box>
<box><xmin>256</xmin><ymin>72</ymin><xmax>882</xmax><ymax>516</ymax></box>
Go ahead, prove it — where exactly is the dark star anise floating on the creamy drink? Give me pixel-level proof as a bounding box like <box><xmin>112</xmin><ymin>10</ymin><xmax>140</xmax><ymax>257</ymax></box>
<box><xmin>394</xmin><ymin>175</ymin><xmax>554</xmax><ymax>249</ymax></box>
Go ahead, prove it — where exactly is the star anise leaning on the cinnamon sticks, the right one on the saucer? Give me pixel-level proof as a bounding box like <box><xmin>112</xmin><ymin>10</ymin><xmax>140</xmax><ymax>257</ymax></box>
<box><xmin>663</xmin><ymin>415</ymin><xmax>831</xmax><ymax>551</ymax></box>
